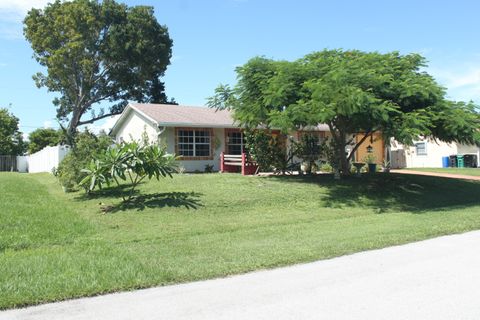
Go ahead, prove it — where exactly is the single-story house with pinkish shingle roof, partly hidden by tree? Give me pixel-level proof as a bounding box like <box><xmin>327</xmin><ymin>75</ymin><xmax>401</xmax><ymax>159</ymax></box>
<box><xmin>110</xmin><ymin>103</ymin><xmax>344</xmax><ymax>172</ymax></box>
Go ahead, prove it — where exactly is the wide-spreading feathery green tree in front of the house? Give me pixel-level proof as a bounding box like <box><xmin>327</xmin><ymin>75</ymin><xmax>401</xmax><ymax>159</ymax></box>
<box><xmin>209</xmin><ymin>50</ymin><xmax>480</xmax><ymax>174</ymax></box>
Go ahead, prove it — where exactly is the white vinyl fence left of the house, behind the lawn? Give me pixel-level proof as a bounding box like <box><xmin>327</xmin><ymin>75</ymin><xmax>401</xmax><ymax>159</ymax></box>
<box><xmin>25</xmin><ymin>146</ymin><xmax>70</xmax><ymax>173</ymax></box>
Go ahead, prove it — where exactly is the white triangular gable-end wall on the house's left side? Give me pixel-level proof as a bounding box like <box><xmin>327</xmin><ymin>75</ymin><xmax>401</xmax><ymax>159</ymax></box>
<box><xmin>115</xmin><ymin>112</ymin><xmax>159</xmax><ymax>143</ymax></box>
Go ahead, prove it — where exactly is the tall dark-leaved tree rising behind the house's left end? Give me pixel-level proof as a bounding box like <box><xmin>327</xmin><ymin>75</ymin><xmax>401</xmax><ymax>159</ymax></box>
<box><xmin>24</xmin><ymin>0</ymin><xmax>173</xmax><ymax>142</ymax></box>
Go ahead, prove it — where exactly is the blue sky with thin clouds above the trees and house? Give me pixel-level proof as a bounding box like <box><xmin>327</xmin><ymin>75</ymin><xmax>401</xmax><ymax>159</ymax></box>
<box><xmin>0</xmin><ymin>0</ymin><xmax>480</xmax><ymax>133</ymax></box>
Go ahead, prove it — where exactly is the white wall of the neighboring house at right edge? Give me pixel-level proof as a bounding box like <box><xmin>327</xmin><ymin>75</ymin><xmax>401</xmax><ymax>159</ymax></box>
<box><xmin>391</xmin><ymin>139</ymin><xmax>479</xmax><ymax>168</ymax></box>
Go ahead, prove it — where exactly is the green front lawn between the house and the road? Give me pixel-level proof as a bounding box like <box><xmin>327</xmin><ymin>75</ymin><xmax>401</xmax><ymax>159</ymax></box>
<box><xmin>0</xmin><ymin>173</ymin><xmax>480</xmax><ymax>309</ymax></box>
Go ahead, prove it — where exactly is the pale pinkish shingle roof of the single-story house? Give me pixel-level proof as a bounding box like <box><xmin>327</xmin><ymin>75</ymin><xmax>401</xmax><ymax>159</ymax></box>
<box><xmin>130</xmin><ymin>103</ymin><xmax>236</xmax><ymax>127</ymax></box>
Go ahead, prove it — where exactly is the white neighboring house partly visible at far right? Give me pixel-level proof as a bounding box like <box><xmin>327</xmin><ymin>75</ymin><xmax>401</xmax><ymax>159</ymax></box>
<box><xmin>390</xmin><ymin>138</ymin><xmax>480</xmax><ymax>168</ymax></box>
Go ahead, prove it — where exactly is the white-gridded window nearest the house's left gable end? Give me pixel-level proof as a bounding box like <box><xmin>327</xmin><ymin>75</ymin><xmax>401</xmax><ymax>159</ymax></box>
<box><xmin>177</xmin><ymin>129</ymin><xmax>212</xmax><ymax>158</ymax></box>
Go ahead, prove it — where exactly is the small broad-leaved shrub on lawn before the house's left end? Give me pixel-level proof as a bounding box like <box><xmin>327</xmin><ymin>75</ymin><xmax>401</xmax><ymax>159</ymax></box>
<box><xmin>80</xmin><ymin>142</ymin><xmax>177</xmax><ymax>202</ymax></box>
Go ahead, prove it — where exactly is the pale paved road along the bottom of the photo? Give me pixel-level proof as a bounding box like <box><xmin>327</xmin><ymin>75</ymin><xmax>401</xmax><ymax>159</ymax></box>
<box><xmin>0</xmin><ymin>231</ymin><xmax>480</xmax><ymax>320</ymax></box>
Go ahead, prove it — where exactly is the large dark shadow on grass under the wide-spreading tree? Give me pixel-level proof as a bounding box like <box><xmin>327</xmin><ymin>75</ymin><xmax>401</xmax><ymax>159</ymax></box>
<box><xmin>267</xmin><ymin>173</ymin><xmax>480</xmax><ymax>213</ymax></box>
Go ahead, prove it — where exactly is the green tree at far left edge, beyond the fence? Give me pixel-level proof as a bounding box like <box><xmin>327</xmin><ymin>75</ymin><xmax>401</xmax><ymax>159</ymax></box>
<box><xmin>0</xmin><ymin>108</ymin><xmax>25</xmax><ymax>156</ymax></box>
